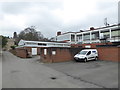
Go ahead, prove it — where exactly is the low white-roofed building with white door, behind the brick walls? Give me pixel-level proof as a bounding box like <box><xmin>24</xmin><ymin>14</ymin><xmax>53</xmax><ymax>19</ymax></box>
<box><xmin>17</xmin><ymin>40</ymin><xmax>70</xmax><ymax>55</ymax></box>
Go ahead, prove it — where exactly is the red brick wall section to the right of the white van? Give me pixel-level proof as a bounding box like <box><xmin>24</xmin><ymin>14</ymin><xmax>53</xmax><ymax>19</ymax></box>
<box><xmin>96</xmin><ymin>47</ymin><xmax>120</xmax><ymax>61</ymax></box>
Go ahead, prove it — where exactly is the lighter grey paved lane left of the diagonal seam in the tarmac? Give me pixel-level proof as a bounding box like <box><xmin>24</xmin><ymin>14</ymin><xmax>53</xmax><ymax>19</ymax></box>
<box><xmin>2</xmin><ymin>52</ymin><xmax>80</xmax><ymax>88</ymax></box>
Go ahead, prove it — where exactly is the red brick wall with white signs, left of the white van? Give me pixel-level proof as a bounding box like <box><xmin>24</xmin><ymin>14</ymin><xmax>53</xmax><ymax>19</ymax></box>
<box><xmin>40</xmin><ymin>47</ymin><xmax>82</xmax><ymax>63</ymax></box>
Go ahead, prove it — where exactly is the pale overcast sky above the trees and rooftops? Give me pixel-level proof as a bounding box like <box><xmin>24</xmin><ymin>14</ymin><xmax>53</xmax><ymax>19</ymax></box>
<box><xmin>0</xmin><ymin>0</ymin><xmax>119</xmax><ymax>38</ymax></box>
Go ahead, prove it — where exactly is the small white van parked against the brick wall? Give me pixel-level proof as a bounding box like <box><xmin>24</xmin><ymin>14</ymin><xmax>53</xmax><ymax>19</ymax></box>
<box><xmin>74</xmin><ymin>49</ymin><xmax>98</xmax><ymax>62</ymax></box>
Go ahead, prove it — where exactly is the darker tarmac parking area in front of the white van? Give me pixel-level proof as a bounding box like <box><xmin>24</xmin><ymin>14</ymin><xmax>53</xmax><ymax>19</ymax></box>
<box><xmin>44</xmin><ymin>60</ymin><xmax>118</xmax><ymax>88</ymax></box>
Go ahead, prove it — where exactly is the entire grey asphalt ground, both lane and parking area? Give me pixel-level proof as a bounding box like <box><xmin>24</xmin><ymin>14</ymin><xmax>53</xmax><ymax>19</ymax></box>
<box><xmin>2</xmin><ymin>52</ymin><xmax>118</xmax><ymax>88</ymax></box>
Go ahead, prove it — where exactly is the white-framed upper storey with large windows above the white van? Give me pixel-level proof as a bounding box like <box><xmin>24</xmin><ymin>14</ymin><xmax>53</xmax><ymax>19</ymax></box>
<box><xmin>54</xmin><ymin>25</ymin><xmax>120</xmax><ymax>44</ymax></box>
